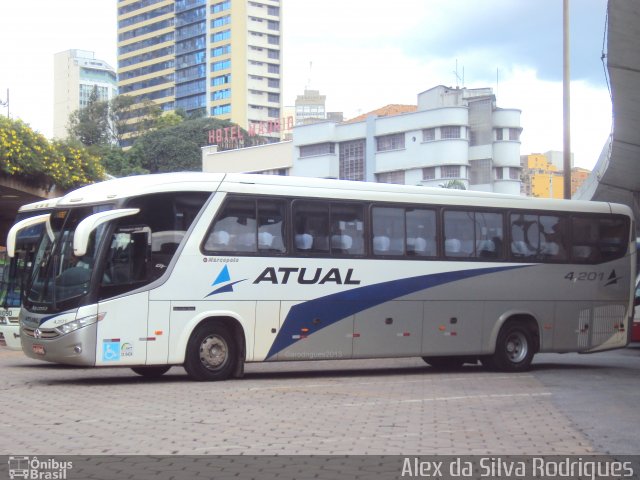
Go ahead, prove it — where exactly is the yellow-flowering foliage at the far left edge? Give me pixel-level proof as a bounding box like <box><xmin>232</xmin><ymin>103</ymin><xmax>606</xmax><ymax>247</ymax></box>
<box><xmin>0</xmin><ymin>117</ymin><xmax>105</xmax><ymax>190</ymax></box>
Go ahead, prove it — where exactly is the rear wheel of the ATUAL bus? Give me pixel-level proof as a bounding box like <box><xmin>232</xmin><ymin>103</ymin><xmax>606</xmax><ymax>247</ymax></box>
<box><xmin>490</xmin><ymin>322</ymin><xmax>535</xmax><ymax>372</ymax></box>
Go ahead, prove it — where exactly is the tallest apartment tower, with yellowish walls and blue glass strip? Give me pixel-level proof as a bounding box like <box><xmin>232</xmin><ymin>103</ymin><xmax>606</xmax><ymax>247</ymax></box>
<box><xmin>118</xmin><ymin>0</ymin><xmax>282</xmax><ymax>146</ymax></box>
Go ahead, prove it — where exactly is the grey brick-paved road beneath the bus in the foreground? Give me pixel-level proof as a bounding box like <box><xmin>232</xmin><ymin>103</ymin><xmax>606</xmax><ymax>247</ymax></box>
<box><xmin>0</xmin><ymin>346</ymin><xmax>640</xmax><ymax>455</ymax></box>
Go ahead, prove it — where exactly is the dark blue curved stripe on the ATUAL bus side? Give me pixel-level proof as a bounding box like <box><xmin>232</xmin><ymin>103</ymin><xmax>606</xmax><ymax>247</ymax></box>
<box><xmin>267</xmin><ymin>265</ymin><xmax>529</xmax><ymax>360</ymax></box>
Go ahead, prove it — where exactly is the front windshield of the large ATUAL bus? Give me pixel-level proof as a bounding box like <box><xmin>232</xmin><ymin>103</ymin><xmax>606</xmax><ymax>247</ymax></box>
<box><xmin>25</xmin><ymin>205</ymin><xmax>112</xmax><ymax>311</ymax></box>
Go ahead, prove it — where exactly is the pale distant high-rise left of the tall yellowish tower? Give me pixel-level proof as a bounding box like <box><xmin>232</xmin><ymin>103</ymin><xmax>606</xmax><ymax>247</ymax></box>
<box><xmin>53</xmin><ymin>49</ymin><xmax>118</xmax><ymax>138</ymax></box>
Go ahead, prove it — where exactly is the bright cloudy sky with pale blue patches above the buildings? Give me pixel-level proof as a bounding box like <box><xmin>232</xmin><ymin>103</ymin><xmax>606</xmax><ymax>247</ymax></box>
<box><xmin>0</xmin><ymin>0</ymin><xmax>611</xmax><ymax>169</ymax></box>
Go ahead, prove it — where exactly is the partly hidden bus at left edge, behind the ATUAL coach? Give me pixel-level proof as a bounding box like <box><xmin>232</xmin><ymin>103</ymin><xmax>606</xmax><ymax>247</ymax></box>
<box><xmin>0</xmin><ymin>199</ymin><xmax>57</xmax><ymax>350</ymax></box>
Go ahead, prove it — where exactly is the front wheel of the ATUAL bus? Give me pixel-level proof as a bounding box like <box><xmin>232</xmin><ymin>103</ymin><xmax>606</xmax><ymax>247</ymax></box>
<box><xmin>184</xmin><ymin>323</ymin><xmax>238</xmax><ymax>382</ymax></box>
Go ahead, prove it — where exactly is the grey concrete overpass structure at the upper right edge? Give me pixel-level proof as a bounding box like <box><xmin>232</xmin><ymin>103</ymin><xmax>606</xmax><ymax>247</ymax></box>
<box><xmin>573</xmin><ymin>0</ymin><xmax>640</xmax><ymax>231</ymax></box>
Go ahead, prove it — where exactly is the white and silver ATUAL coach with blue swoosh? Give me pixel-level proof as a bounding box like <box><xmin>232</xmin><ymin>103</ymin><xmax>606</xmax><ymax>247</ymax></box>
<box><xmin>8</xmin><ymin>173</ymin><xmax>636</xmax><ymax>380</ymax></box>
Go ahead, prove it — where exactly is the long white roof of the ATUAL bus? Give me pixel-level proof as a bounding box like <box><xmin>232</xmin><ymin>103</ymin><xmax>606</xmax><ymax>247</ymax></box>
<box><xmin>53</xmin><ymin>172</ymin><xmax>632</xmax><ymax>216</ymax></box>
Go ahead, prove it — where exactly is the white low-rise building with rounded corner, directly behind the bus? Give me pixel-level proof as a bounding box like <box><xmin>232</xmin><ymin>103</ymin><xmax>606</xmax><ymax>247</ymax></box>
<box><xmin>203</xmin><ymin>86</ymin><xmax>522</xmax><ymax>195</ymax></box>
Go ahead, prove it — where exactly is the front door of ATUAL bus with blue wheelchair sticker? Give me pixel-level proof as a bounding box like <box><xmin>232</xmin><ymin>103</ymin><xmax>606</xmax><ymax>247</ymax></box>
<box><xmin>96</xmin><ymin>226</ymin><xmax>151</xmax><ymax>366</ymax></box>
